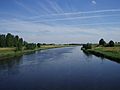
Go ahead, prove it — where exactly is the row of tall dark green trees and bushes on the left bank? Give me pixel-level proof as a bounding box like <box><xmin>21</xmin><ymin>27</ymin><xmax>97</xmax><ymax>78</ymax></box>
<box><xmin>0</xmin><ymin>33</ymin><xmax>41</xmax><ymax>51</ymax></box>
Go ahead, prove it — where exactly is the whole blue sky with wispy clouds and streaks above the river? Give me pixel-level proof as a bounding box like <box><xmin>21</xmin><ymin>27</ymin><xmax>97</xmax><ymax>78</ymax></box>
<box><xmin>0</xmin><ymin>0</ymin><xmax>120</xmax><ymax>43</ymax></box>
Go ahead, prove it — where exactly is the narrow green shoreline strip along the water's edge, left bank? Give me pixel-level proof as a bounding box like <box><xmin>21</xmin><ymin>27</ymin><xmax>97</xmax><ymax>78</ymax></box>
<box><xmin>0</xmin><ymin>45</ymin><xmax>76</xmax><ymax>61</ymax></box>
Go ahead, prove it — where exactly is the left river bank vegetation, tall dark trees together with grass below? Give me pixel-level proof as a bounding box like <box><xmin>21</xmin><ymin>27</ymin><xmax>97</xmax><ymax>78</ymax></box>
<box><xmin>0</xmin><ymin>33</ymin><xmax>77</xmax><ymax>60</ymax></box>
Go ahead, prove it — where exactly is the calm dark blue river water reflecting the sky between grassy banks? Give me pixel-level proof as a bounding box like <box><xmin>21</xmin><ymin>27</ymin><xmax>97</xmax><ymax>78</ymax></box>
<box><xmin>0</xmin><ymin>47</ymin><xmax>120</xmax><ymax>90</ymax></box>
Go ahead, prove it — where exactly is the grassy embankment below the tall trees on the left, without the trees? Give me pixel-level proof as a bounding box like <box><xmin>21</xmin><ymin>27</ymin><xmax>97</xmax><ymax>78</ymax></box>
<box><xmin>0</xmin><ymin>45</ymin><xmax>75</xmax><ymax>60</ymax></box>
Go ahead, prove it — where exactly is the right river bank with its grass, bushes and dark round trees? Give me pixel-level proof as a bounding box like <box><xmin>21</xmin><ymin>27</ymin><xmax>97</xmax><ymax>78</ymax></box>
<box><xmin>81</xmin><ymin>39</ymin><xmax>120</xmax><ymax>62</ymax></box>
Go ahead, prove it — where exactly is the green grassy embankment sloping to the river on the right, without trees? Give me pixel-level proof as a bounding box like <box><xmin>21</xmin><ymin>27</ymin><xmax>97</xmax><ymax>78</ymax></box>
<box><xmin>82</xmin><ymin>45</ymin><xmax>120</xmax><ymax>62</ymax></box>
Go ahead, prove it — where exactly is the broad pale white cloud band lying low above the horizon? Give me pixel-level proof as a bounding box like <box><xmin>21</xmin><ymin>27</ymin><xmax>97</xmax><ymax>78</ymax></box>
<box><xmin>0</xmin><ymin>20</ymin><xmax>120</xmax><ymax>43</ymax></box>
